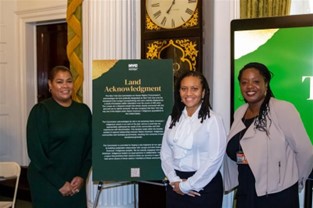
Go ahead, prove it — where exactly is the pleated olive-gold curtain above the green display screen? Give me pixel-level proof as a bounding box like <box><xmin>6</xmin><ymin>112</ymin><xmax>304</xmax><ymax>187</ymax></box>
<box><xmin>240</xmin><ymin>0</ymin><xmax>291</xmax><ymax>19</ymax></box>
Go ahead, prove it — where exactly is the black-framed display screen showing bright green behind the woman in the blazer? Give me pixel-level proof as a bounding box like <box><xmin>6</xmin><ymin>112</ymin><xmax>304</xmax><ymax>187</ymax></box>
<box><xmin>231</xmin><ymin>14</ymin><xmax>313</xmax><ymax>143</ymax></box>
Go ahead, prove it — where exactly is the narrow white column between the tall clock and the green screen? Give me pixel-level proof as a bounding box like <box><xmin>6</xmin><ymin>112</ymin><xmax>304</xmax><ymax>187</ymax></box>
<box><xmin>211</xmin><ymin>0</ymin><xmax>240</xmax><ymax>208</ymax></box>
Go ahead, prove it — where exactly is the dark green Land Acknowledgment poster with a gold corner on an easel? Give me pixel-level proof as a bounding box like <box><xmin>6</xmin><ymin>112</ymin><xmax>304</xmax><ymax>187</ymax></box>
<box><xmin>92</xmin><ymin>60</ymin><xmax>173</xmax><ymax>181</ymax></box>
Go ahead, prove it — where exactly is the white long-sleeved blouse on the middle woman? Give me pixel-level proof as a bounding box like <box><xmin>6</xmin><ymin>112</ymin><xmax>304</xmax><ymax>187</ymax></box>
<box><xmin>160</xmin><ymin>106</ymin><xmax>226</xmax><ymax>193</ymax></box>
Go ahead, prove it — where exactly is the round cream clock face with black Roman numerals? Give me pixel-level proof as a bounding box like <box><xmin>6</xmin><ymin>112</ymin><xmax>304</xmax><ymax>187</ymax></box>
<box><xmin>146</xmin><ymin>0</ymin><xmax>198</xmax><ymax>29</ymax></box>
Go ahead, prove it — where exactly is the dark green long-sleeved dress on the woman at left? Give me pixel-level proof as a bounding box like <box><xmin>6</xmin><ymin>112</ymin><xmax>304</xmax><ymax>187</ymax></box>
<box><xmin>27</xmin><ymin>98</ymin><xmax>91</xmax><ymax>208</ymax></box>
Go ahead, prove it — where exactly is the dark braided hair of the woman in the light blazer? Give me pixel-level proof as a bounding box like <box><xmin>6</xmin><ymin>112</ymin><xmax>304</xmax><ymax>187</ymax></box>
<box><xmin>238</xmin><ymin>62</ymin><xmax>275</xmax><ymax>134</ymax></box>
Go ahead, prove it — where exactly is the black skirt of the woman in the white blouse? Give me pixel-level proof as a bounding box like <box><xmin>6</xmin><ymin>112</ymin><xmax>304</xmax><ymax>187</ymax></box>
<box><xmin>166</xmin><ymin>171</ymin><xmax>223</xmax><ymax>208</ymax></box>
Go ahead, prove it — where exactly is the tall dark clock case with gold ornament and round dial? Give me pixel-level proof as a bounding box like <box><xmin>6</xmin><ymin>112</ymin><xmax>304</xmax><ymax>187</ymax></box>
<box><xmin>141</xmin><ymin>0</ymin><xmax>202</xmax><ymax>77</ymax></box>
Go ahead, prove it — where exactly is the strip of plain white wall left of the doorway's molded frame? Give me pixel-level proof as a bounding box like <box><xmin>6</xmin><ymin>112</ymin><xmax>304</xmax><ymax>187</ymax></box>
<box><xmin>0</xmin><ymin>0</ymin><xmax>25</xmax><ymax>163</ymax></box>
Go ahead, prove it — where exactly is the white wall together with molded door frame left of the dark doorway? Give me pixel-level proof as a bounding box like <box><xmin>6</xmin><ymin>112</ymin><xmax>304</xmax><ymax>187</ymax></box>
<box><xmin>0</xmin><ymin>0</ymin><xmax>67</xmax><ymax>165</ymax></box>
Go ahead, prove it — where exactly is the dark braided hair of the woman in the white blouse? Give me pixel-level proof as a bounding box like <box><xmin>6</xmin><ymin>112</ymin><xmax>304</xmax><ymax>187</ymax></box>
<box><xmin>169</xmin><ymin>71</ymin><xmax>212</xmax><ymax>129</ymax></box>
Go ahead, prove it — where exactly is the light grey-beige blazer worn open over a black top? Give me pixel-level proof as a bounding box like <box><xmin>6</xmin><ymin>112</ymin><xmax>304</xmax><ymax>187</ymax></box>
<box><xmin>224</xmin><ymin>98</ymin><xmax>313</xmax><ymax>196</ymax></box>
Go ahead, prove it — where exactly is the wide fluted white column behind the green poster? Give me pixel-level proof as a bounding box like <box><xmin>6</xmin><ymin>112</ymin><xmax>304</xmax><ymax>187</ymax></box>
<box><xmin>83</xmin><ymin>0</ymin><xmax>140</xmax><ymax>208</ymax></box>
